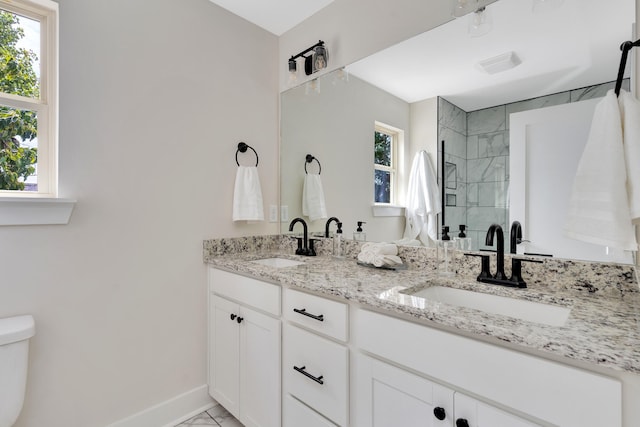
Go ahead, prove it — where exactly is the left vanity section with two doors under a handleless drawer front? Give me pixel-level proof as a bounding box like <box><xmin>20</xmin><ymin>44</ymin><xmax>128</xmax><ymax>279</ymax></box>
<box><xmin>209</xmin><ymin>269</ymin><xmax>281</xmax><ymax>427</ymax></box>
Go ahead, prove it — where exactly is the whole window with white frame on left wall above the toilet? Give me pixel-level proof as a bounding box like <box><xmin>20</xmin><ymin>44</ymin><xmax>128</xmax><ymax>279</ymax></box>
<box><xmin>0</xmin><ymin>0</ymin><xmax>58</xmax><ymax>197</ymax></box>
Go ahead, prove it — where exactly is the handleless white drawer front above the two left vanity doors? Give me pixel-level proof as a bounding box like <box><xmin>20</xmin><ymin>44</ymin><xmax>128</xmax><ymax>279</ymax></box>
<box><xmin>209</xmin><ymin>268</ymin><xmax>281</xmax><ymax>316</ymax></box>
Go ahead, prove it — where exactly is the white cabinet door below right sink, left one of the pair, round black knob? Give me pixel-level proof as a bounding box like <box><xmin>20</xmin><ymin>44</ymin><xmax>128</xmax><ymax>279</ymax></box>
<box><xmin>353</xmin><ymin>354</ymin><xmax>454</xmax><ymax>427</ymax></box>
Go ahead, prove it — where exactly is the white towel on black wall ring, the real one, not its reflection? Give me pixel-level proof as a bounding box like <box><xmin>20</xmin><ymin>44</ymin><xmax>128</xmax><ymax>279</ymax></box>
<box><xmin>233</xmin><ymin>166</ymin><xmax>264</xmax><ymax>221</ymax></box>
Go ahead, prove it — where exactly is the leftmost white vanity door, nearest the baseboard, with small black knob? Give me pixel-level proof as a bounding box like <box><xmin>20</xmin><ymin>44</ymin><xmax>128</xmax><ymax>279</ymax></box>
<box><xmin>209</xmin><ymin>295</ymin><xmax>240</xmax><ymax>417</ymax></box>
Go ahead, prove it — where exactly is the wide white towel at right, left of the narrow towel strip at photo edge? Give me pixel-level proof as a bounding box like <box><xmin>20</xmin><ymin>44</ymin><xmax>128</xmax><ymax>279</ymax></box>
<box><xmin>564</xmin><ymin>90</ymin><xmax>638</xmax><ymax>251</ymax></box>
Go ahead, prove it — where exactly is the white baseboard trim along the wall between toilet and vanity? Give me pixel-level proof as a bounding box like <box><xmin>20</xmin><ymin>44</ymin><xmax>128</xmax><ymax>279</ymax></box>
<box><xmin>107</xmin><ymin>384</ymin><xmax>216</xmax><ymax>427</ymax></box>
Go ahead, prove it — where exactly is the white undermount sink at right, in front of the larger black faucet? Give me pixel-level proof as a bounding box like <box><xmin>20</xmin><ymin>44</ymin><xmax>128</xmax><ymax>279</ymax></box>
<box><xmin>411</xmin><ymin>286</ymin><xmax>571</xmax><ymax>326</ymax></box>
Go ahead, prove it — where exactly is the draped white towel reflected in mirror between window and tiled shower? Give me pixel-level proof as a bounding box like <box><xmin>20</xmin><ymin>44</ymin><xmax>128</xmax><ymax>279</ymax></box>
<box><xmin>403</xmin><ymin>150</ymin><xmax>442</xmax><ymax>246</ymax></box>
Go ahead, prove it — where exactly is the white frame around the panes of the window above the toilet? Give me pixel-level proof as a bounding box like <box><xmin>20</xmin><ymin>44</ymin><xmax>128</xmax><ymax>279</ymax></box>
<box><xmin>0</xmin><ymin>0</ymin><xmax>58</xmax><ymax>200</ymax></box>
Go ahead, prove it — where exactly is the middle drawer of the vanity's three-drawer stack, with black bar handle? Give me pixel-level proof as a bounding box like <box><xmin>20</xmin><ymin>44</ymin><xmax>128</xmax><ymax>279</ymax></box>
<box><xmin>282</xmin><ymin>325</ymin><xmax>349</xmax><ymax>426</ymax></box>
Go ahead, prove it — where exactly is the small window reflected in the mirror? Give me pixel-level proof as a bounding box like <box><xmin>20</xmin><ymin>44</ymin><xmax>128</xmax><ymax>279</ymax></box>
<box><xmin>373</xmin><ymin>123</ymin><xmax>402</xmax><ymax>204</ymax></box>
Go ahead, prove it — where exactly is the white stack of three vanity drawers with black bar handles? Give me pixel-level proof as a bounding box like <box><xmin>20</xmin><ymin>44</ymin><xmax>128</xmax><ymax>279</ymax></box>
<box><xmin>282</xmin><ymin>289</ymin><xmax>349</xmax><ymax>427</ymax></box>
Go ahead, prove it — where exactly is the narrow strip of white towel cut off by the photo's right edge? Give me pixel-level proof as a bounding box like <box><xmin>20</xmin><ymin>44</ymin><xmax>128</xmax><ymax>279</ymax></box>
<box><xmin>618</xmin><ymin>90</ymin><xmax>640</xmax><ymax>219</ymax></box>
